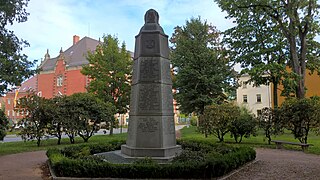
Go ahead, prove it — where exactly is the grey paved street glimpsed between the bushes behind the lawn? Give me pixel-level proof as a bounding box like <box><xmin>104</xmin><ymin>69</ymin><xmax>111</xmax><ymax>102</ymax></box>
<box><xmin>3</xmin><ymin>125</ymin><xmax>185</xmax><ymax>142</ymax></box>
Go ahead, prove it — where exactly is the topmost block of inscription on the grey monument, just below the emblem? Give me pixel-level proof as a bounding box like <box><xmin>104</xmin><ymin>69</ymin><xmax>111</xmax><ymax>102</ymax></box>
<box><xmin>140</xmin><ymin>58</ymin><xmax>160</xmax><ymax>81</ymax></box>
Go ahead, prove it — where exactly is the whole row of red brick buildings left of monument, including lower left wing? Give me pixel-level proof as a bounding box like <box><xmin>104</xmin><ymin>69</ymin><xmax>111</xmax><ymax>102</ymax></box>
<box><xmin>0</xmin><ymin>35</ymin><xmax>99</xmax><ymax>123</ymax></box>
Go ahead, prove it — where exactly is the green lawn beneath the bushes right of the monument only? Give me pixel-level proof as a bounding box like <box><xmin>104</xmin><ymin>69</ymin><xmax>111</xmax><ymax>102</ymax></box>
<box><xmin>181</xmin><ymin>126</ymin><xmax>320</xmax><ymax>155</ymax></box>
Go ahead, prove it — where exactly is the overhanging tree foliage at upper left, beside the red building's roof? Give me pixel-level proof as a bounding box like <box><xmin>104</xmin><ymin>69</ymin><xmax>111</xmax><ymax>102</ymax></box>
<box><xmin>0</xmin><ymin>0</ymin><xmax>36</xmax><ymax>94</ymax></box>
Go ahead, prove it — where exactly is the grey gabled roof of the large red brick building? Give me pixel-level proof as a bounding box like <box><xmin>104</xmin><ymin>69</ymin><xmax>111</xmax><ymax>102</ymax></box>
<box><xmin>40</xmin><ymin>37</ymin><xmax>99</xmax><ymax>71</ymax></box>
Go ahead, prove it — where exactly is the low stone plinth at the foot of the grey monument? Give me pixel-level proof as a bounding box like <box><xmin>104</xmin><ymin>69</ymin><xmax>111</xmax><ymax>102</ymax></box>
<box><xmin>121</xmin><ymin>145</ymin><xmax>181</xmax><ymax>159</ymax></box>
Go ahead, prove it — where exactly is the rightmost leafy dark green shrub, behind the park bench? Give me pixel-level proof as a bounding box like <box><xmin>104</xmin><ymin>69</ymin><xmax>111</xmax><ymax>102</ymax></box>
<box><xmin>280</xmin><ymin>97</ymin><xmax>320</xmax><ymax>143</ymax></box>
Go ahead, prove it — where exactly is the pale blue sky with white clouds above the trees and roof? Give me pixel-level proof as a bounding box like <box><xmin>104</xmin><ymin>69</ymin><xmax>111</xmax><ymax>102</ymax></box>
<box><xmin>9</xmin><ymin>0</ymin><xmax>234</xmax><ymax>64</ymax></box>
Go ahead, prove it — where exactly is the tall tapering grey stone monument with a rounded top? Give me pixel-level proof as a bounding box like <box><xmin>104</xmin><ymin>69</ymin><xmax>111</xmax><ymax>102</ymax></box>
<box><xmin>121</xmin><ymin>9</ymin><xmax>181</xmax><ymax>159</ymax></box>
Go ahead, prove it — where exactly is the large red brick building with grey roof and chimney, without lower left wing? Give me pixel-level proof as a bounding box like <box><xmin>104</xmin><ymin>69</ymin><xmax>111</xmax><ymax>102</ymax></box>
<box><xmin>37</xmin><ymin>36</ymin><xmax>99</xmax><ymax>98</ymax></box>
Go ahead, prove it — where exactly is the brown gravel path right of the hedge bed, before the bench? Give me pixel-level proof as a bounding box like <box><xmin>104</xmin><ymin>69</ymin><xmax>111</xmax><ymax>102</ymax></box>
<box><xmin>226</xmin><ymin>149</ymin><xmax>320</xmax><ymax>180</ymax></box>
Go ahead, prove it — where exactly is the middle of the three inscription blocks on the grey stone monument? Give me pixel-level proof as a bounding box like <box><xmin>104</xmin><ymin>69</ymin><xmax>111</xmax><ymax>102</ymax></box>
<box><xmin>139</xmin><ymin>84</ymin><xmax>161</xmax><ymax>111</ymax></box>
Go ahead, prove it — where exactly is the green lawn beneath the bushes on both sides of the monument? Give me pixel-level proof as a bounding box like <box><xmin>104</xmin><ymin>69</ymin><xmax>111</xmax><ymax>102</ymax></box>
<box><xmin>0</xmin><ymin>126</ymin><xmax>320</xmax><ymax>156</ymax></box>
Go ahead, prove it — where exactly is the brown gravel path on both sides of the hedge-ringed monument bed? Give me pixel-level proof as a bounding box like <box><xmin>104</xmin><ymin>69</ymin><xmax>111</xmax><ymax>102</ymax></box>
<box><xmin>0</xmin><ymin>149</ymin><xmax>320</xmax><ymax>180</ymax></box>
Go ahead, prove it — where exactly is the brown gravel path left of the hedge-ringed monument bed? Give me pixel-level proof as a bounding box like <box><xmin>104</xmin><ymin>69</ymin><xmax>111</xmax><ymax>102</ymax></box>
<box><xmin>0</xmin><ymin>151</ymin><xmax>47</xmax><ymax>180</ymax></box>
